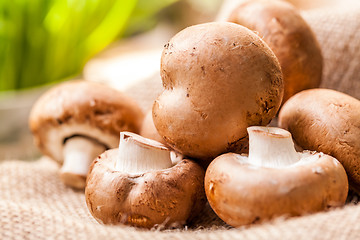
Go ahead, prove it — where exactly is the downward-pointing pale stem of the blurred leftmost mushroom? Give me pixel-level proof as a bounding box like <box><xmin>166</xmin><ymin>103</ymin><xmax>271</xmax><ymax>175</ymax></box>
<box><xmin>60</xmin><ymin>136</ymin><xmax>106</xmax><ymax>189</ymax></box>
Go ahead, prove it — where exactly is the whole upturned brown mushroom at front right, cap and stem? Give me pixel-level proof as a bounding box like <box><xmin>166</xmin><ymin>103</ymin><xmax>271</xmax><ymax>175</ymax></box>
<box><xmin>205</xmin><ymin>127</ymin><xmax>348</xmax><ymax>227</ymax></box>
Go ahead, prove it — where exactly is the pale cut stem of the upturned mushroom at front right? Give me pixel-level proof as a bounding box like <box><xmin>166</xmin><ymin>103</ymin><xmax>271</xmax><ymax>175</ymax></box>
<box><xmin>247</xmin><ymin>126</ymin><xmax>300</xmax><ymax>168</ymax></box>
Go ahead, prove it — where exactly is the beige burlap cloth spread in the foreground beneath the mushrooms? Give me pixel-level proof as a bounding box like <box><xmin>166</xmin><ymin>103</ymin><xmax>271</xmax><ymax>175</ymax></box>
<box><xmin>0</xmin><ymin>158</ymin><xmax>360</xmax><ymax>240</ymax></box>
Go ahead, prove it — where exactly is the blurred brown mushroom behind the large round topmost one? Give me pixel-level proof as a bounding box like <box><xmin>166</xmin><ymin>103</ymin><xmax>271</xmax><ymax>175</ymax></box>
<box><xmin>227</xmin><ymin>0</ymin><xmax>323</xmax><ymax>103</ymax></box>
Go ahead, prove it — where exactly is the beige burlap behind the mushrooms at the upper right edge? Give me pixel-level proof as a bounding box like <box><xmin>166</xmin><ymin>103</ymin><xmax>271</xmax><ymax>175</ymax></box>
<box><xmin>303</xmin><ymin>1</ymin><xmax>360</xmax><ymax>98</ymax></box>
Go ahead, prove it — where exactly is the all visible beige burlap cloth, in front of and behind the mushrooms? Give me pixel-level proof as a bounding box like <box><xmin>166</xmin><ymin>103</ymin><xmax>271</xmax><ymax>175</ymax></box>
<box><xmin>0</xmin><ymin>2</ymin><xmax>360</xmax><ymax>240</ymax></box>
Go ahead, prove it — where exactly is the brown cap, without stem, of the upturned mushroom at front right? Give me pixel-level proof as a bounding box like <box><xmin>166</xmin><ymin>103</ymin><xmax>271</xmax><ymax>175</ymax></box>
<box><xmin>205</xmin><ymin>153</ymin><xmax>348</xmax><ymax>227</ymax></box>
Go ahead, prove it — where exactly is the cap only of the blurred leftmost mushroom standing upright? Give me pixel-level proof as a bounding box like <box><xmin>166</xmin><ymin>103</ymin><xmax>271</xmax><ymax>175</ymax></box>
<box><xmin>29</xmin><ymin>81</ymin><xmax>143</xmax><ymax>162</ymax></box>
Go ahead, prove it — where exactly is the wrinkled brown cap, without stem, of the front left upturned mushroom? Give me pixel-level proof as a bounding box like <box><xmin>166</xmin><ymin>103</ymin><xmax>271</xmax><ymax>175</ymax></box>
<box><xmin>85</xmin><ymin>149</ymin><xmax>206</xmax><ymax>228</ymax></box>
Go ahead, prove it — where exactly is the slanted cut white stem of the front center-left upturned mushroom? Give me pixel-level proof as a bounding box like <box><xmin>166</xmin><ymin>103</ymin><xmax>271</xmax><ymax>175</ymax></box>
<box><xmin>115</xmin><ymin>132</ymin><xmax>173</xmax><ymax>174</ymax></box>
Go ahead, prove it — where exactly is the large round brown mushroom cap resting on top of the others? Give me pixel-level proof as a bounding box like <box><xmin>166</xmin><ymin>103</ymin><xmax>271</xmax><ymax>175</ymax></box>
<box><xmin>153</xmin><ymin>22</ymin><xmax>283</xmax><ymax>161</ymax></box>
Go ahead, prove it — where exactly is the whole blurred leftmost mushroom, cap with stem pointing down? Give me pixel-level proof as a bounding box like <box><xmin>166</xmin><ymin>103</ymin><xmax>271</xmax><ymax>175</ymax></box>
<box><xmin>29</xmin><ymin>81</ymin><xmax>143</xmax><ymax>189</ymax></box>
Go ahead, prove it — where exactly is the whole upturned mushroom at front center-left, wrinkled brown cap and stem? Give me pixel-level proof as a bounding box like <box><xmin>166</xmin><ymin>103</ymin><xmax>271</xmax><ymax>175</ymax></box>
<box><xmin>85</xmin><ymin>132</ymin><xmax>205</xmax><ymax>228</ymax></box>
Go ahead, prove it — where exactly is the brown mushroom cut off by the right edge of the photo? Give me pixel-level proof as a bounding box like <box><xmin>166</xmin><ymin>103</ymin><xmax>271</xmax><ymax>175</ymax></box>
<box><xmin>279</xmin><ymin>89</ymin><xmax>360</xmax><ymax>192</ymax></box>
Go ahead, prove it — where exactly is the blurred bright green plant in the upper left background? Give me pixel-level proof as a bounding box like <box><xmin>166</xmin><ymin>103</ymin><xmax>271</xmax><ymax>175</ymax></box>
<box><xmin>0</xmin><ymin>0</ymin><xmax>177</xmax><ymax>91</ymax></box>
